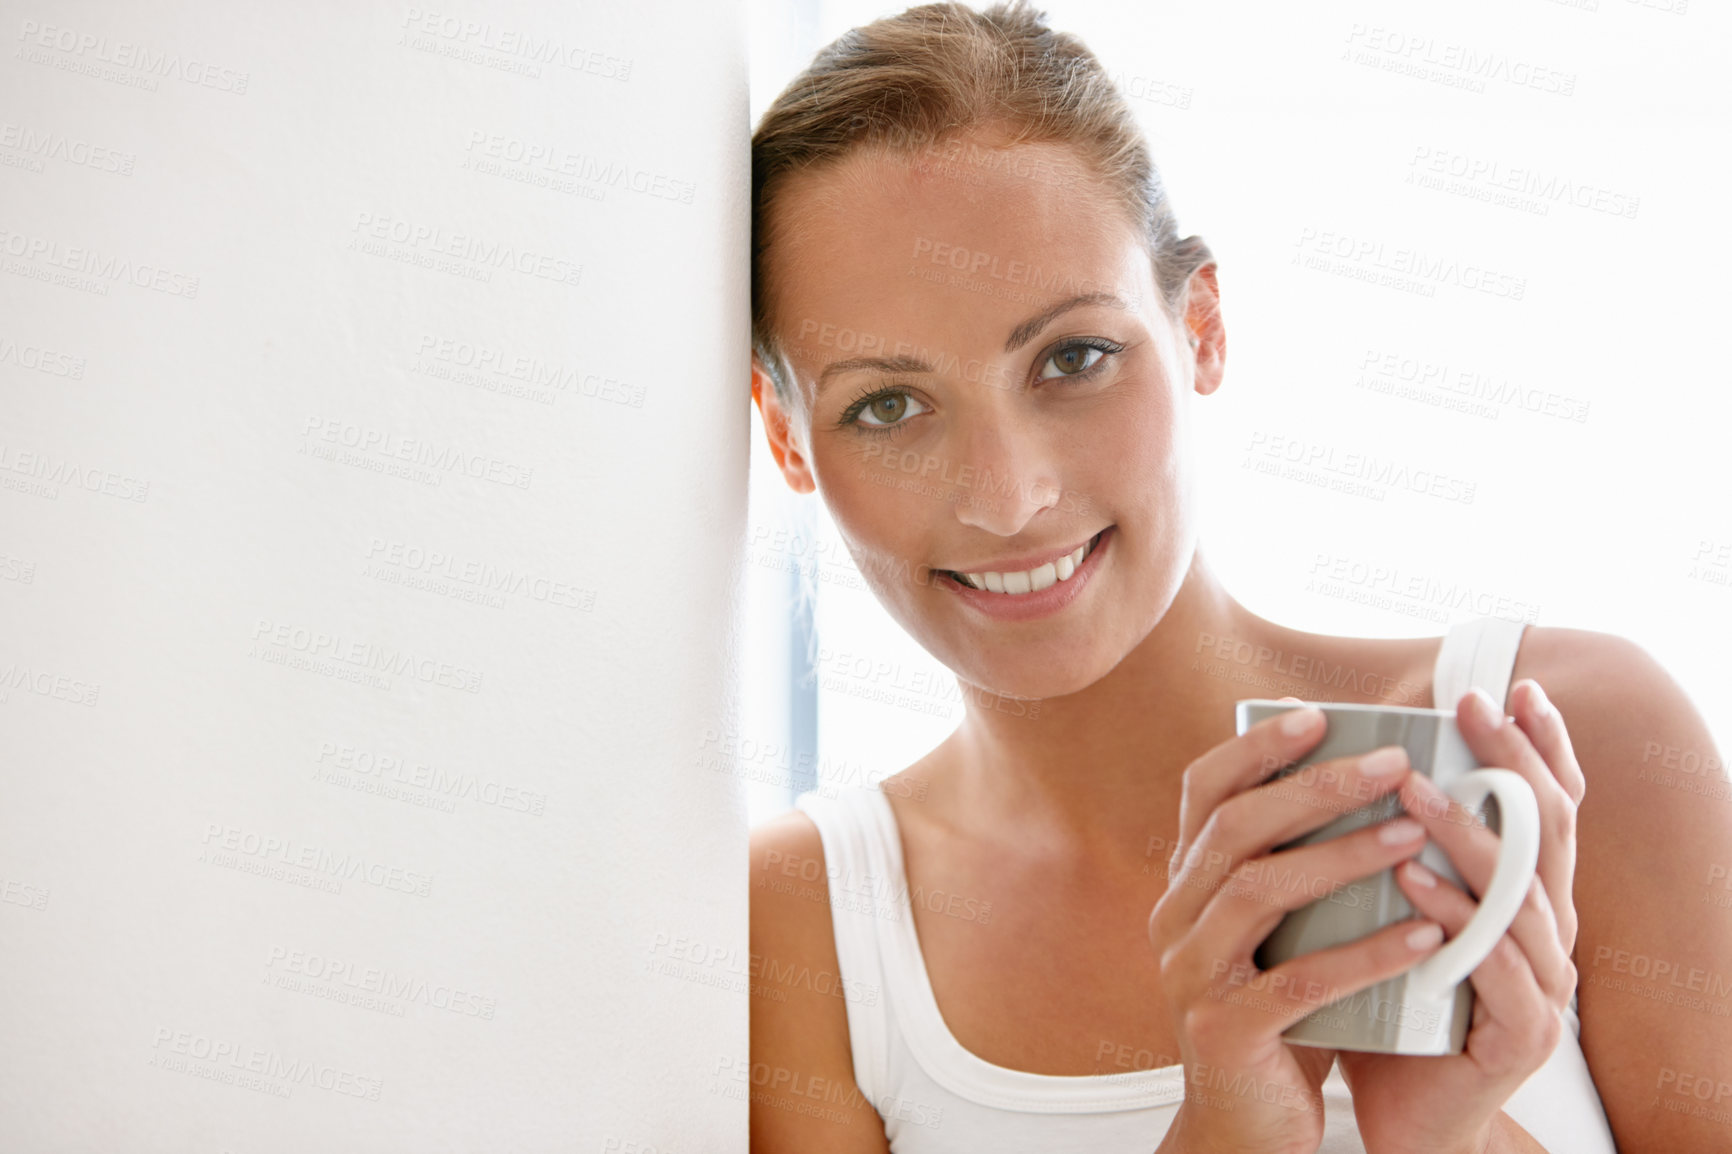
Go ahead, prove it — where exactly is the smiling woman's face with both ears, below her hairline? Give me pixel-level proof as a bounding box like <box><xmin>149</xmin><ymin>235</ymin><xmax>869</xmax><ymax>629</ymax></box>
<box><xmin>755</xmin><ymin>129</ymin><xmax>1223</xmax><ymax>697</ymax></box>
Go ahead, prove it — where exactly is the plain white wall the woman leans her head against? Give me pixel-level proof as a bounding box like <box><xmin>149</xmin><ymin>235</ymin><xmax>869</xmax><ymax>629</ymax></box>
<box><xmin>0</xmin><ymin>0</ymin><xmax>748</xmax><ymax>1154</ymax></box>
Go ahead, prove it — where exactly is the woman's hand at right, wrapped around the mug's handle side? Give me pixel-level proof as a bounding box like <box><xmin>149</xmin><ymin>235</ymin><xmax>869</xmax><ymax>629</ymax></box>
<box><xmin>1341</xmin><ymin>681</ymin><xmax>1585</xmax><ymax>1154</ymax></box>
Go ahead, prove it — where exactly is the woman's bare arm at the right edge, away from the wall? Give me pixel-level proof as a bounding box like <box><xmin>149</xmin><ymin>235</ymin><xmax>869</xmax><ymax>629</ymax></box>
<box><xmin>1535</xmin><ymin>629</ymin><xmax>1732</xmax><ymax>1154</ymax></box>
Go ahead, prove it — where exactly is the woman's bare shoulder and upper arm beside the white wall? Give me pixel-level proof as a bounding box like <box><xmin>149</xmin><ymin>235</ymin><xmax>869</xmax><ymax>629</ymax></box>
<box><xmin>748</xmin><ymin>809</ymin><xmax>890</xmax><ymax>1154</ymax></box>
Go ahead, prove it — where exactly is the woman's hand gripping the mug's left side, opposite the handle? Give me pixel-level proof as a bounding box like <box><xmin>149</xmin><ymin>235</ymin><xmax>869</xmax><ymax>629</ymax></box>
<box><xmin>1148</xmin><ymin>709</ymin><xmax>1443</xmax><ymax>1154</ymax></box>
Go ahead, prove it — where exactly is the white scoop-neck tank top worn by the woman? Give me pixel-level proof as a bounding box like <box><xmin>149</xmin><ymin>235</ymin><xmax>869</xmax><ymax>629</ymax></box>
<box><xmin>795</xmin><ymin>617</ymin><xmax>1618</xmax><ymax>1154</ymax></box>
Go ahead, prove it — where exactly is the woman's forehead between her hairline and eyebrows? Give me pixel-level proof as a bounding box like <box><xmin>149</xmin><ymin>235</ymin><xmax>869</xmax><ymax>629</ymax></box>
<box><xmin>771</xmin><ymin>142</ymin><xmax>1154</xmax><ymax>385</ymax></box>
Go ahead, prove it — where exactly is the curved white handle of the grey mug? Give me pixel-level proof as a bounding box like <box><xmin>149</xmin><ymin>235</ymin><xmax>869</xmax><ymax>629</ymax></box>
<box><xmin>1408</xmin><ymin>769</ymin><xmax>1540</xmax><ymax>996</ymax></box>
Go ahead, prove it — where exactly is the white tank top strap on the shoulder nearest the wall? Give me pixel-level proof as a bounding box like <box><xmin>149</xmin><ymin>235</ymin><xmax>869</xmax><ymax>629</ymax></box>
<box><xmin>793</xmin><ymin>788</ymin><xmax>895</xmax><ymax>1104</ymax></box>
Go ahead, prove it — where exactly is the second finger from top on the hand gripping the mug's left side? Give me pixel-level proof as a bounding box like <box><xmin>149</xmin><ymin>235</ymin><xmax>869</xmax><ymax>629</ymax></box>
<box><xmin>1162</xmin><ymin>745</ymin><xmax>1410</xmax><ymax>924</ymax></box>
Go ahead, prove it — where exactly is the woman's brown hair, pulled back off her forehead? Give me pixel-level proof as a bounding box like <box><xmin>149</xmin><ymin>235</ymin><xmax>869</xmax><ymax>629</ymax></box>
<box><xmin>752</xmin><ymin>0</ymin><xmax>1214</xmax><ymax>402</ymax></box>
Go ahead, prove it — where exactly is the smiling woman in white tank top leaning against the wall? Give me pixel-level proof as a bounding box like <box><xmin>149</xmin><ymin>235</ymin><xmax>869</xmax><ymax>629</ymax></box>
<box><xmin>750</xmin><ymin>3</ymin><xmax>1732</xmax><ymax>1154</ymax></box>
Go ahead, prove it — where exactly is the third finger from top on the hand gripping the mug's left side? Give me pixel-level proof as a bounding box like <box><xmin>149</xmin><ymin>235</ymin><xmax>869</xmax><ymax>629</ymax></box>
<box><xmin>1178</xmin><ymin>816</ymin><xmax>1425</xmax><ymax>969</ymax></box>
